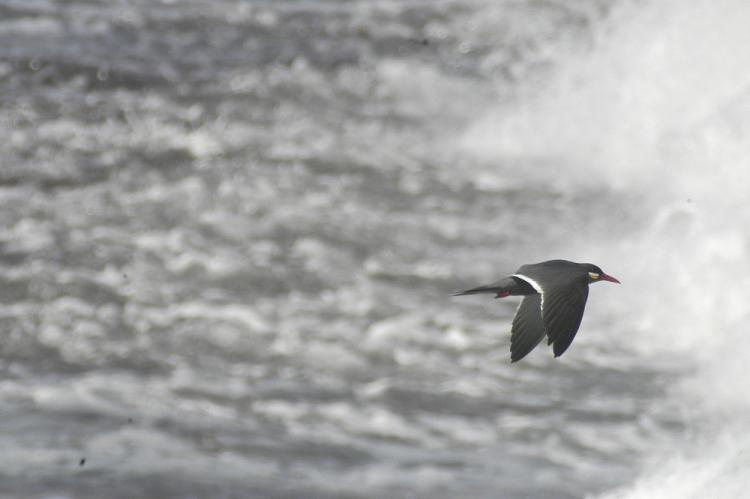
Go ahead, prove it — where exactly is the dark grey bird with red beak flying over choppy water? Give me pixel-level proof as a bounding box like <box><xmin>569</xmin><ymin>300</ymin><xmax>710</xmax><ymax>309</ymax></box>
<box><xmin>453</xmin><ymin>260</ymin><xmax>620</xmax><ymax>362</ymax></box>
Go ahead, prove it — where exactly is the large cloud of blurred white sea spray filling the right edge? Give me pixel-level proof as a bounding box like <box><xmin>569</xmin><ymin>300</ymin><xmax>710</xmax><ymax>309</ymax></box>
<box><xmin>463</xmin><ymin>0</ymin><xmax>750</xmax><ymax>498</ymax></box>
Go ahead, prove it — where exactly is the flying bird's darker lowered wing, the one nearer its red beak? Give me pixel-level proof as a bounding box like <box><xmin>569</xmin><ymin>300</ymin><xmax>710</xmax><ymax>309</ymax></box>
<box><xmin>541</xmin><ymin>282</ymin><xmax>589</xmax><ymax>357</ymax></box>
